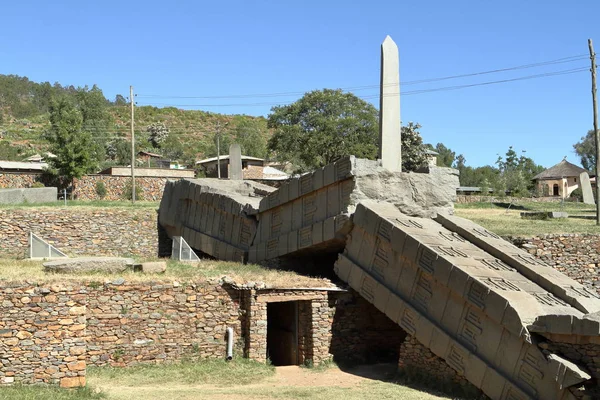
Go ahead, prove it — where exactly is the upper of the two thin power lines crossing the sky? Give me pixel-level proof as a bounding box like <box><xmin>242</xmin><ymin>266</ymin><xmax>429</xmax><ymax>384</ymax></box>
<box><xmin>137</xmin><ymin>54</ymin><xmax>588</xmax><ymax>99</ymax></box>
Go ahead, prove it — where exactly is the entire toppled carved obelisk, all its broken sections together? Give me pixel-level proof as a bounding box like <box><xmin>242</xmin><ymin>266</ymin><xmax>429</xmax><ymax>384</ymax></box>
<box><xmin>159</xmin><ymin>157</ymin><xmax>600</xmax><ymax>400</ymax></box>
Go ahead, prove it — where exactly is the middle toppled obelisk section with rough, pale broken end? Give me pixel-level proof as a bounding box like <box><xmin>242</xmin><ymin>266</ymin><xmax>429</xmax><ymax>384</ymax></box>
<box><xmin>249</xmin><ymin>156</ymin><xmax>458</xmax><ymax>262</ymax></box>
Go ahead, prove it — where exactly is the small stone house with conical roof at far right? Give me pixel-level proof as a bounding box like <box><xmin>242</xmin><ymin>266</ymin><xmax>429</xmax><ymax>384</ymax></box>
<box><xmin>533</xmin><ymin>159</ymin><xmax>587</xmax><ymax>199</ymax></box>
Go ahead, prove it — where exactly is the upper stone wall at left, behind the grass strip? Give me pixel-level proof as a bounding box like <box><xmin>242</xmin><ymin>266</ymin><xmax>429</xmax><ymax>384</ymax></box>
<box><xmin>0</xmin><ymin>207</ymin><xmax>158</xmax><ymax>257</ymax></box>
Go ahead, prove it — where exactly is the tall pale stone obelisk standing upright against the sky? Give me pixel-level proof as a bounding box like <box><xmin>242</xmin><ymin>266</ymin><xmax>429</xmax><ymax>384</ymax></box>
<box><xmin>379</xmin><ymin>36</ymin><xmax>402</xmax><ymax>171</ymax></box>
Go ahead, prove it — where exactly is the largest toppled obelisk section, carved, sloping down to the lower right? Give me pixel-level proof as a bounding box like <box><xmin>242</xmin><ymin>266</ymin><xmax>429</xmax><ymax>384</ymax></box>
<box><xmin>335</xmin><ymin>202</ymin><xmax>600</xmax><ymax>399</ymax></box>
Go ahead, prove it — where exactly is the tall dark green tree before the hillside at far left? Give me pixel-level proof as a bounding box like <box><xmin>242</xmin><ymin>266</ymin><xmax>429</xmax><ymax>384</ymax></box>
<box><xmin>46</xmin><ymin>97</ymin><xmax>97</xmax><ymax>198</ymax></box>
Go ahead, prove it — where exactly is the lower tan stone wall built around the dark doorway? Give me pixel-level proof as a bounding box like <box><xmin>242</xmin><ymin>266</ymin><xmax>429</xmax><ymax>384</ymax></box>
<box><xmin>0</xmin><ymin>279</ymin><xmax>404</xmax><ymax>387</ymax></box>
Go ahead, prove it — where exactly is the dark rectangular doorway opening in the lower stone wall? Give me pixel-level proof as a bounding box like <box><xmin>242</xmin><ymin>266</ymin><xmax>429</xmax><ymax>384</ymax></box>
<box><xmin>267</xmin><ymin>301</ymin><xmax>298</xmax><ymax>366</ymax></box>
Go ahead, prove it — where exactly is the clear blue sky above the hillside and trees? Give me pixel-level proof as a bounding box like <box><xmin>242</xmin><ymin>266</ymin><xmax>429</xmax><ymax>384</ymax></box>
<box><xmin>0</xmin><ymin>0</ymin><xmax>600</xmax><ymax>167</ymax></box>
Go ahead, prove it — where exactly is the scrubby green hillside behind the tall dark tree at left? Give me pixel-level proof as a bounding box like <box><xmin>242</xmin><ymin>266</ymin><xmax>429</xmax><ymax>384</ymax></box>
<box><xmin>0</xmin><ymin>75</ymin><xmax>270</xmax><ymax>166</ymax></box>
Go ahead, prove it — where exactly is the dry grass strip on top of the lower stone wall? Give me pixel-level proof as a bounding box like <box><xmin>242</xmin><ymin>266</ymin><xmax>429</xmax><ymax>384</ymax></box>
<box><xmin>0</xmin><ymin>259</ymin><xmax>331</xmax><ymax>288</ymax></box>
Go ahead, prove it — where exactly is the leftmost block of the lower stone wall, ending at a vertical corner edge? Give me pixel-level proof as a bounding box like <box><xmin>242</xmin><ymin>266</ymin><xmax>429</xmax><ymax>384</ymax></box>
<box><xmin>0</xmin><ymin>283</ymin><xmax>87</xmax><ymax>387</ymax></box>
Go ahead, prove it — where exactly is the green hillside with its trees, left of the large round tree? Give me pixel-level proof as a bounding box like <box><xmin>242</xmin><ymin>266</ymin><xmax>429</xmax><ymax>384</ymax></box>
<box><xmin>0</xmin><ymin>75</ymin><xmax>268</xmax><ymax>172</ymax></box>
